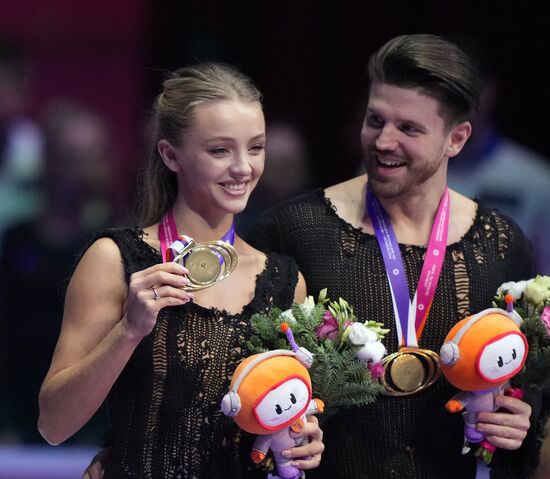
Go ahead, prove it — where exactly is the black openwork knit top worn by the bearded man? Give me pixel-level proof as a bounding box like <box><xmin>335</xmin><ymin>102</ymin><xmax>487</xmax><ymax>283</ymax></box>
<box><xmin>248</xmin><ymin>190</ymin><xmax>540</xmax><ymax>479</ymax></box>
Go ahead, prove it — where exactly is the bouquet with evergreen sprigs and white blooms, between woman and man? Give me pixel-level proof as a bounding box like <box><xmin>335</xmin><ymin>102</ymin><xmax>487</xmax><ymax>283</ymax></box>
<box><xmin>247</xmin><ymin>289</ymin><xmax>389</xmax><ymax>414</ymax></box>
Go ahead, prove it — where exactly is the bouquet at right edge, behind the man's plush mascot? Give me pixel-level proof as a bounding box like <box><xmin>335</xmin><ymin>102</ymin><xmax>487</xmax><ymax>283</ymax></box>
<box><xmin>494</xmin><ymin>276</ymin><xmax>550</xmax><ymax>391</ymax></box>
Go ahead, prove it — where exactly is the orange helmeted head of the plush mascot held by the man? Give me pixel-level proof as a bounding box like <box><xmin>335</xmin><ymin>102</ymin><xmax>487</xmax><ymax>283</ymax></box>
<box><xmin>441</xmin><ymin>312</ymin><xmax>528</xmax><ymax>391</ymax></box>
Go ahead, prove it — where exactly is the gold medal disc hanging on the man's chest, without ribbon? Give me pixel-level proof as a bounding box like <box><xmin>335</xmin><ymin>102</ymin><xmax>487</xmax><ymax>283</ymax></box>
<box><xmin>380</xmin><ymin>348</ymin><xmax>441</xmax><ymax>396</ymax></box>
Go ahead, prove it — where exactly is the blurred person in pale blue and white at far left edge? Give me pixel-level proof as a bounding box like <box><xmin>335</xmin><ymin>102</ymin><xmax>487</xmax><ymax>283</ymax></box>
<box><xmin>0</xmin><ymin>34</ymin><xmax>42</xmax><ymax>242</ymax></box>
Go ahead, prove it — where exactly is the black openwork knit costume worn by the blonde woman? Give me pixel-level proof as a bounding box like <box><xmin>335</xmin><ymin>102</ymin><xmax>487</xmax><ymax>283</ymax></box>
<box><xmin>85</xmin><ymin>229</ymin><xmax>298</xmax><ymax>479</ymax></box>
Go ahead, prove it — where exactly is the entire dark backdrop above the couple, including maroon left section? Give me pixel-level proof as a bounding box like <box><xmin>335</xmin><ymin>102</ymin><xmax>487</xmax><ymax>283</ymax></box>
<box><xmin>0</xmin><ymin>0</ymin><xmax>550</xmax><ymax>202</ymax></box>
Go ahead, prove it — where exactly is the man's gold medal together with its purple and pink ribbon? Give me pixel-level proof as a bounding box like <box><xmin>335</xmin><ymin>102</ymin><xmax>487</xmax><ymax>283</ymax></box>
<box><xmin>367</xmin><ymin>188</ymin><xmax>450</xmax><ymax>396</ymax></box>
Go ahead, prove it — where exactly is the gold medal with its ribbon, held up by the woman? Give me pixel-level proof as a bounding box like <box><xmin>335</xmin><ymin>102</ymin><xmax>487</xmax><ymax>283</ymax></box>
<box><xmin>158</xmin><ymin>210</ymin><xmax>238</xmax><ymax>291</ymax></box>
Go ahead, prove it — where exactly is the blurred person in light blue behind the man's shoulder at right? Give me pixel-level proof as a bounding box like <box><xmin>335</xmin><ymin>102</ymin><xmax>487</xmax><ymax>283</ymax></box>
<box><xmin>448</xmin><ymin>36</ymin><xmax>550</xmax><ymax>274</ymax></box>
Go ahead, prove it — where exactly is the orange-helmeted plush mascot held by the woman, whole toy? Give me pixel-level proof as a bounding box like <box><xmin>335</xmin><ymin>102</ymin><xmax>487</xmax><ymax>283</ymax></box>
<box><xmin>221</xmin><ymin>323</ymin><xmax>323</xmax><ymax>479</ymax></box>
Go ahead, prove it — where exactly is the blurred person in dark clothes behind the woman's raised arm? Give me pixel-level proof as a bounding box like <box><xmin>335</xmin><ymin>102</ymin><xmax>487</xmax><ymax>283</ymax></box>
<box><xmin>0</xmin><ymin>101</ymin><xmax>114</xmax><ymax>443</ymax></box>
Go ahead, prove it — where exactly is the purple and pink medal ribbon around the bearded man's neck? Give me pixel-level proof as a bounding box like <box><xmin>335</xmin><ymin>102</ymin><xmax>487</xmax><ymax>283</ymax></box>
<box><xmin>367</xmin><ymin>188</ymin><xmax>450</xmax><ymax>348</ymax></box>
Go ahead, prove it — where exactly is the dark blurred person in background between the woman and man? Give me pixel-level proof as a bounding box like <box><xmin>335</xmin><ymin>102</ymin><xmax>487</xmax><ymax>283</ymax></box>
<box><xmin>236</xmin><ymin>121</ymin><xmax>312</xmax><ymax>234</ymax></box>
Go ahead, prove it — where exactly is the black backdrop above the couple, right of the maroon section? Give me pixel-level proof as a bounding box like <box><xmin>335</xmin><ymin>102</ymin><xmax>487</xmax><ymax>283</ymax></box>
<box><xmin>149</xmin><ymin>0</ymin><xmax>550</xmax><ymax>185</ymax></box>
